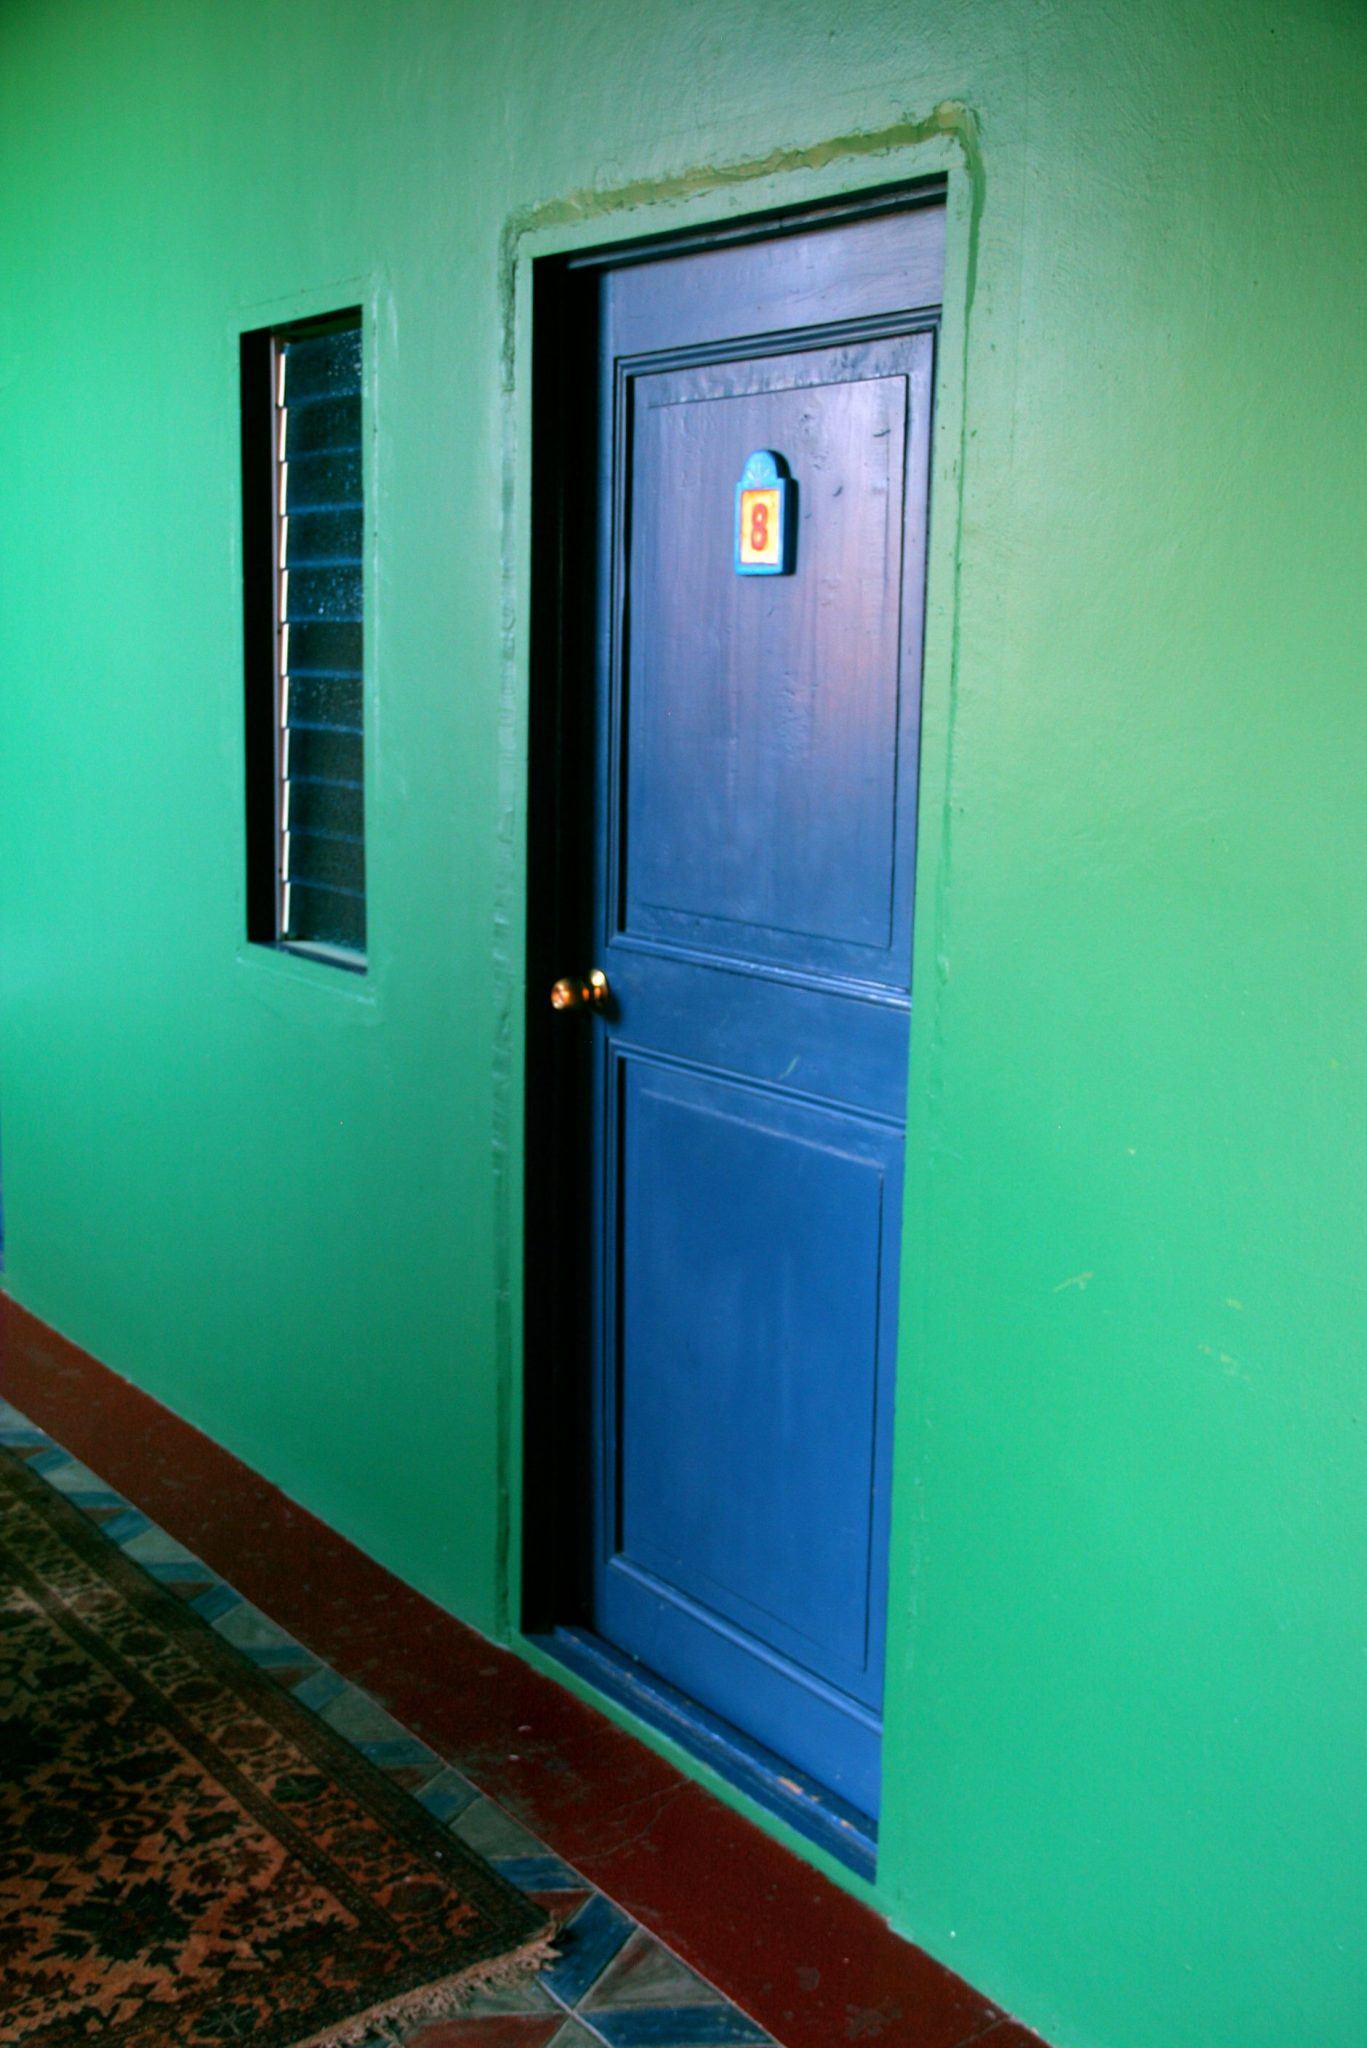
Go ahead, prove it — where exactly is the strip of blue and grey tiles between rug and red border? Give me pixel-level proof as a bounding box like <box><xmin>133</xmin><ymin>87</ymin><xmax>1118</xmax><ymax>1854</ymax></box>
<box><xmin>0</xmin><ymin>1401</ymin><xmax>773</xmax><ymax>2048</ymax></box>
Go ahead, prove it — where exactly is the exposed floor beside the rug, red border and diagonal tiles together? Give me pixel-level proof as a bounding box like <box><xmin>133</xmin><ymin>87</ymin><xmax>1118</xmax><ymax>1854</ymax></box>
<box><xmin>0</xmin><ymin>1294</ymin><xmax>1041</xmax><ymax>2048</ymax></box>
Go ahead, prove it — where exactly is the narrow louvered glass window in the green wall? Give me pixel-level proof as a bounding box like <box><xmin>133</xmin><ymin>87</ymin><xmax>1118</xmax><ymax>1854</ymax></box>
<box><xmin>242</xmin><ymin>311</ymin><xmax>365</xmax><ymax>967</ymax></box>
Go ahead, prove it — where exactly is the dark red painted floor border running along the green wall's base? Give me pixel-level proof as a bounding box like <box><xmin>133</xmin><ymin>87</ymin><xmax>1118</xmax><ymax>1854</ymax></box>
<box><xmin>0</xmin><ymin>1296</ymin><xmax>1039</xmax><ymax>2048</ymax></box>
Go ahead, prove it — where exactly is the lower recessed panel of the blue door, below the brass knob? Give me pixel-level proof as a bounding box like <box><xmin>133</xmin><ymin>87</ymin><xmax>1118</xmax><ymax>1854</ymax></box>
<box><xmin>605</xmin><ymin>1053</ymin><xmax>900</xmax><ymax>1706</ymax></box>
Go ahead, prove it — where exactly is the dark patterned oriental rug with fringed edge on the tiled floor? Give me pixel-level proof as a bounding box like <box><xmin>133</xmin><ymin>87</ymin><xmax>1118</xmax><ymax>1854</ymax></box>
<box><xmin>0</xmin><ymin>1450</ymin><xmax>547</xmax><ymax>2048</ymax></box>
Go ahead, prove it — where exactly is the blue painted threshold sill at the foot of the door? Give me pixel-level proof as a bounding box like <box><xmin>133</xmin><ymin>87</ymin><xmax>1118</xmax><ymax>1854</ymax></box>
<box><xmin>527</xmin><ymin>1628</ymin><xmax>877</xmax><ymax>1882</ymax></box>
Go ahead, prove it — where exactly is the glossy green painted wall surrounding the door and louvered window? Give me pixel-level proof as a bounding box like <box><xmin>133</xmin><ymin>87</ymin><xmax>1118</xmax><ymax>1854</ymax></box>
<box><xmin>0</xmin><ymin>0</ymin><xmax>1367</xmax><ymax>2048</ymax></box>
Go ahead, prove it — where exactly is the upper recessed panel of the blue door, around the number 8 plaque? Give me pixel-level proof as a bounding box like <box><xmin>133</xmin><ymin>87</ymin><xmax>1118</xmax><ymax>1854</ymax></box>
<box><xmin>619</xmin><ymin>336</ymin><xmax>930</xmax><ymax>991</ymax></box>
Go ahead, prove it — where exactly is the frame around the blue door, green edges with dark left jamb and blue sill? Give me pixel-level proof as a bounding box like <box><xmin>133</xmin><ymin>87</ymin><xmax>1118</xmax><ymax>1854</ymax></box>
<box><xmin>508</xmin><ymin>140</ymin><xmax>982</xmax><ymax>1901</ymax></box>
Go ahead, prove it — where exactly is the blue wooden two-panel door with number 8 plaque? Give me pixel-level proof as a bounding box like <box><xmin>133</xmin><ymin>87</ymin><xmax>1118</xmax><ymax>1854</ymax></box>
<box><xmin>573</xmin><ymin>215</ymin><xmax>941</xmax><ymax>1815</ymax></box>
